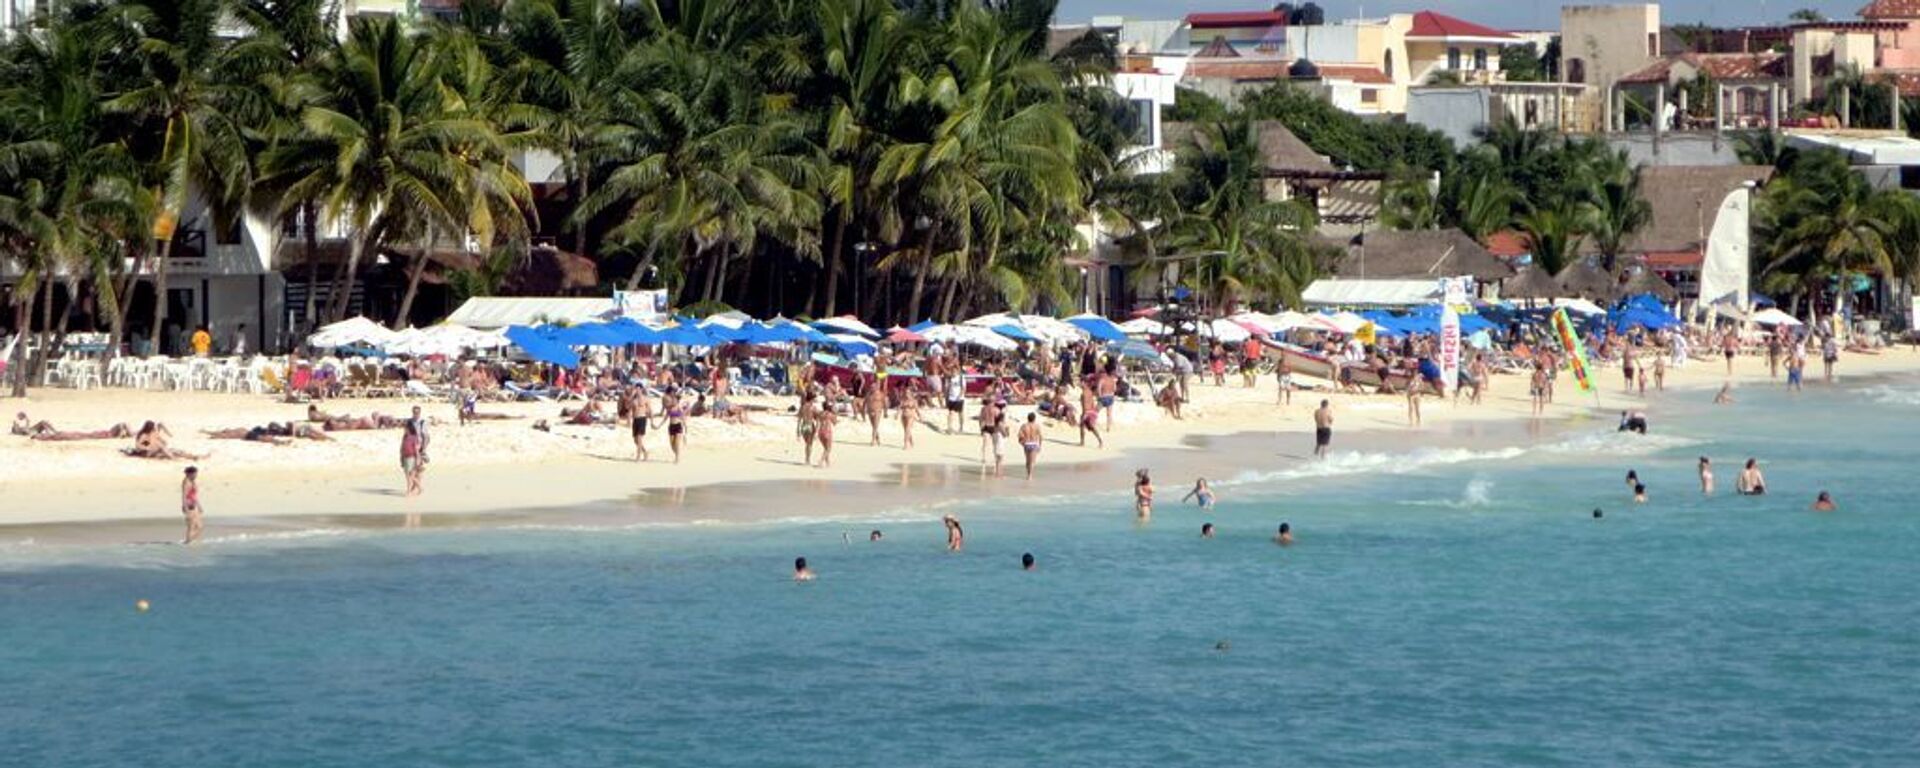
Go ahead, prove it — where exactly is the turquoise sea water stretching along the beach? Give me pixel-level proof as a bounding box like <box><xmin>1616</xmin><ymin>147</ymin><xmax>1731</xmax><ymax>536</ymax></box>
<box><xmin>0</xmin><ymin>380</ymin><xmax>1920</xmax><ymax>768</ymax></box>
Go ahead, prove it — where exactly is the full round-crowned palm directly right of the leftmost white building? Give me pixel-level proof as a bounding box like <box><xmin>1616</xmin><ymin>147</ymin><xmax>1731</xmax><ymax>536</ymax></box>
<box><xmin>257</xmin><ymin>17</ymin><xmax>499</xmax><ymax>319</ymax></box>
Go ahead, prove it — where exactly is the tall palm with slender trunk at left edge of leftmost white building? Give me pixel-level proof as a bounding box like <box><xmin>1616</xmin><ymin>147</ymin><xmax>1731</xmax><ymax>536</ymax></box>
<box><xmin>106</xmin><ymin>0</ymin><xmax>252</xmax><ymax>349</ymax></box>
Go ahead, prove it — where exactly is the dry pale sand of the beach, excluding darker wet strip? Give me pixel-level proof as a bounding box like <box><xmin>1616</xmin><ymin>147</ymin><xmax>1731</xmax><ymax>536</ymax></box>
<box><xmin>0</xmin><ymin>348</ymin><xmax>1920</xmax><ymax>541</ymax></box>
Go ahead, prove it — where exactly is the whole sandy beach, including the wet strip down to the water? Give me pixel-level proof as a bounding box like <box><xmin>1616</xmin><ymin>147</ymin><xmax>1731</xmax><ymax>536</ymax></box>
<box><xmin>0</xmin><ymin>348</ymin><xmax>1920</xmax><ymax>547</ymax></box>
